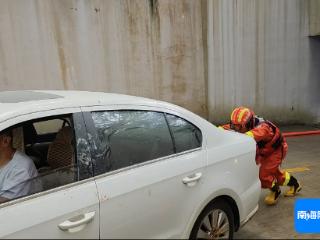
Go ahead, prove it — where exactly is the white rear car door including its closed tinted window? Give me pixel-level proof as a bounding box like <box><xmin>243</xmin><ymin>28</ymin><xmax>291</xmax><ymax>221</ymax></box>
<box><xmin>84</xmin><ymin>108</ymin><xmax>206</xmax><ymax>239</ymax></box>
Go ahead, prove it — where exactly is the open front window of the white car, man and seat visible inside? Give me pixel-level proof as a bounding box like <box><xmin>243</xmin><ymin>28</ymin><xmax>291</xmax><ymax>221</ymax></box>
<box><xmin>0</xmin><ymin>113</ymin><xmax>93</xmax><ymax>203</ymax></box>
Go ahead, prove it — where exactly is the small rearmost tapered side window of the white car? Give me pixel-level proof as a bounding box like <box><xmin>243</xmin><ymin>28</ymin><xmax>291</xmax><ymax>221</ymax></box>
<box><xmin>166</xmin><ymin>113</ymin><xmax>202</xmax><ymax>153</ymax></box>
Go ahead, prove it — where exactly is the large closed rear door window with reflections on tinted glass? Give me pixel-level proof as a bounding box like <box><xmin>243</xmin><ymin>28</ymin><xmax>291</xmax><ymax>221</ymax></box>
<box><xmin>92</xmin><ymin>110</ymin><xmax>174</xmax><ymax>174</ymax></box>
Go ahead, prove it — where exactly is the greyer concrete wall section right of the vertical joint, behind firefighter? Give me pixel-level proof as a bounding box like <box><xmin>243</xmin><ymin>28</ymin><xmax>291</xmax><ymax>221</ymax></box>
<box><xmin>208</xmin><ymin>0</ymin><xmax>320</xmax><ymax>123</ymax></box>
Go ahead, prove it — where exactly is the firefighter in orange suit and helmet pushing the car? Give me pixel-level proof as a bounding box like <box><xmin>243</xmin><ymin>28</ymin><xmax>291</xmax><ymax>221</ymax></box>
<box><xmin>220</xmin><ymin>107</ymin><xmax>301</xmax><ymax>205</ymax></box>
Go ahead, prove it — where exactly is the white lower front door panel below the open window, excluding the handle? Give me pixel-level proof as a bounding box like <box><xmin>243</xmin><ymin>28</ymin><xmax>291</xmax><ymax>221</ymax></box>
<box><xmin>0</xmin><ymin>180</ymin><xmax>99</xmax><ymax>239</ymax></box>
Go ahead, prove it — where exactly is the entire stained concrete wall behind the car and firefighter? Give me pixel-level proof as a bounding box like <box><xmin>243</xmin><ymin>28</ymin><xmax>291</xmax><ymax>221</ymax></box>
<box><xmin>0</xmin><ymin>0</ymin><xmax>320</xmax><ymax>123</ymax></box>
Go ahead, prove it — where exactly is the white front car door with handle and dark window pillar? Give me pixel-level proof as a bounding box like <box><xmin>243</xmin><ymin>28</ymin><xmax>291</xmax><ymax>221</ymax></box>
<box><xmin>0</xmin><ymin>109</ymin><xmax>99</xmax><ymax>239</ymax></box>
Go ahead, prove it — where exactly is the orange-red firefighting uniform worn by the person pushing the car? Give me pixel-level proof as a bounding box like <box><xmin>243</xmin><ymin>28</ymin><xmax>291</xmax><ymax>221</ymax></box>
<box><xmin>222</xmin><ymin>117</ymin><xmax>290</xmax><ymax>188</ymax></box>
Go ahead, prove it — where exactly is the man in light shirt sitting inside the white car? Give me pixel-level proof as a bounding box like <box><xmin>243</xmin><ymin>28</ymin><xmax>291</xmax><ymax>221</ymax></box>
<box><xmin>0</xmin><ymin>129</ymin><xmax>38</xmax><ymax>203</ymax></box>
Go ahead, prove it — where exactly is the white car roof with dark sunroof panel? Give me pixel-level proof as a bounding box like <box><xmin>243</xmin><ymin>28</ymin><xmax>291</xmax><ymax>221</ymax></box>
<box><xmin>0</xmin><ymin>90</ymin><xmax>185</xmax><ymax>122</ymax></box>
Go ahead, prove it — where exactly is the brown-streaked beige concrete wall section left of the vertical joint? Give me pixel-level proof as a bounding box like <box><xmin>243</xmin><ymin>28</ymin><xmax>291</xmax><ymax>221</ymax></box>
<box><xmin>0</xmin><ymin>0</ymin><xmax>206</xmax><ymax>116</ymax></box>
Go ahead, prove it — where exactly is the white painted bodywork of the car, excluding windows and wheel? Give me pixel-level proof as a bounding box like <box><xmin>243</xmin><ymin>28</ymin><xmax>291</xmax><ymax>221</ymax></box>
<box><xmin>0</xmin><ymin>90</ymin><xmax>261</xmax><ymax>238</ymax></box>
